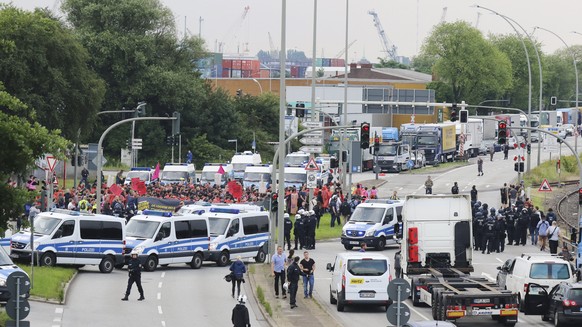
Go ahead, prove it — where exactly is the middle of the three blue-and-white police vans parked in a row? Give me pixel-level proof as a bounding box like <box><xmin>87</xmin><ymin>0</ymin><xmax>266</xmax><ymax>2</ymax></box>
<box><xmin>125</xmin><ymin>210</ymin><xmax>210</xmax><ymax>271</ymax></box>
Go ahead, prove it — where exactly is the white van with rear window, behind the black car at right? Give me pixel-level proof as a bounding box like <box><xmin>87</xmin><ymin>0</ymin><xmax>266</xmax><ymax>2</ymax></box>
<box><xmin>497</xmin><ymin>253</ymin><xmax>576</xmax><ymax>309</ymax></box>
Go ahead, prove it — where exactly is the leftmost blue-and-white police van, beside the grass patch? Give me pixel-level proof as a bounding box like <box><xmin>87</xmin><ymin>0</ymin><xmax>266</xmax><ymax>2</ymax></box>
<box><xmin>10</xmin><ymin>209</ymin><xmax>125</xmax><ymax>273</ymax></box>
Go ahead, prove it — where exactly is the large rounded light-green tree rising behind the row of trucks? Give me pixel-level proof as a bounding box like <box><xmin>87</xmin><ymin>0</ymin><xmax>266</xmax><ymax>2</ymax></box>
<box><xmin>421</xmin><ymin>22</ymin><xmax>511</xmax><ymax>103</ymax></box>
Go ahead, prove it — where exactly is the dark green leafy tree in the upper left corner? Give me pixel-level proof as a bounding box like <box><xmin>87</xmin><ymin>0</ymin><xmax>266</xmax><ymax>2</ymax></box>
<box><xmin>0</xmin><ymin>5</ymin><xmax>105</xmax><ymax>138</ymax></box>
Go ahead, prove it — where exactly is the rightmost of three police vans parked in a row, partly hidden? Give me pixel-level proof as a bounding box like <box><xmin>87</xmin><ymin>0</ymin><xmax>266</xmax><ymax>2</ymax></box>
<box><xmin>204</xmin><ymin>207</ymin><xmax>271</xmax><ymax>266</ymax></box>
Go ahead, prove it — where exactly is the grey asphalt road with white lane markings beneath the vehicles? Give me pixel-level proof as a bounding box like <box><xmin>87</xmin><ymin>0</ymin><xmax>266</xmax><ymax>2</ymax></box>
<box><xmin>21</xmin><ymin>138</ymin><xmax>573</xmax><ymax>327</ymax></box>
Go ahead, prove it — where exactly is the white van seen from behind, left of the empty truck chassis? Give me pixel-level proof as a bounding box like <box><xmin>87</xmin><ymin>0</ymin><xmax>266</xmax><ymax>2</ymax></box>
<box><xmin>327</xmin><ymin>252</ymin><xmax>392</xmax><ymax>311</ymax></box>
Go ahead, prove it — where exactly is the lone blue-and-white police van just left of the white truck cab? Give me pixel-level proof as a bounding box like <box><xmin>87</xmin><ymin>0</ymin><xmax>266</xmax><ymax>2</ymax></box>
<box><xmin>341</xmin><ymin>199</ymin><xmax>404</xmax><ymax>250</ymax></box>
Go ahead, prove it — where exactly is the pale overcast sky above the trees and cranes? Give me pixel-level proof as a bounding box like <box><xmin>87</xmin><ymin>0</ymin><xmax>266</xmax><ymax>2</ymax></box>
<box><xmin>0</xmin><ymin>0</ymin><xmax>582</xmax><ymax>62</ymax></box>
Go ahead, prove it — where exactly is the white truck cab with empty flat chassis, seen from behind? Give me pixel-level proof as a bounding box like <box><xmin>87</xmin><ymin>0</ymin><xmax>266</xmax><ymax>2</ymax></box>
<box><xmin>398</xmin><ymin>194</ymin><xmax>518</xmax><ymax>326</ymax></box>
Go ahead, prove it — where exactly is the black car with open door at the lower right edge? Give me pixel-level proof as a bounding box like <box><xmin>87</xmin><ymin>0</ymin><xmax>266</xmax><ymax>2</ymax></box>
<box><xmin>524</xmin><ymin>282</ymin><xmax>582</xmax><ymax>326</ymax></box>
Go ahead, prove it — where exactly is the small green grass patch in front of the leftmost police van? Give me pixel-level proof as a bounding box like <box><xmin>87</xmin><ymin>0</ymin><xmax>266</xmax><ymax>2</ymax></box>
<box><xmin>20</xmin><ymin>265</ymin><xmax>77</xmax><ymax>303</ymax></box>
